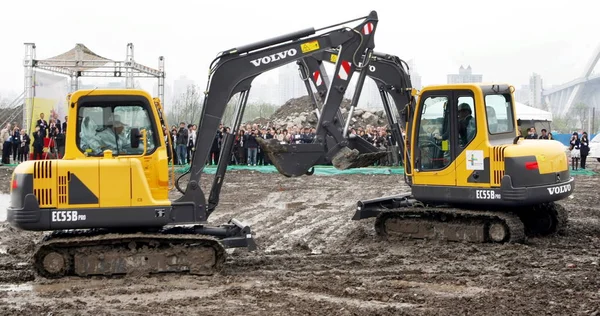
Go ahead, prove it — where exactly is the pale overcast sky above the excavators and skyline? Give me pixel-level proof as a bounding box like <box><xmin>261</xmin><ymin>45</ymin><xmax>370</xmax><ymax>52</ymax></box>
<box><xmin>0</xmin><ymin>0</ymin><xmax>600</xmax><ymax>98</ymax></box>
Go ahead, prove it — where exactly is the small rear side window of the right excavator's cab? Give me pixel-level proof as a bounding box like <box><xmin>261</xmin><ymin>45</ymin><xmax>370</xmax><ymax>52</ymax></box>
<box><xmin>485</xmin><ymin>94</ymin><xmax>515</xmax><ymax>134</ymax></box>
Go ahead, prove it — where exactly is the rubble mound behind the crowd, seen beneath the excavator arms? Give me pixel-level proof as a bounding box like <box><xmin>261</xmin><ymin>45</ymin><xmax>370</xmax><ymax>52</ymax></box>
<box><xmin>253</xmin><ymin>95</ymin><xmax>387</xmax><ymax>128</ymax></box>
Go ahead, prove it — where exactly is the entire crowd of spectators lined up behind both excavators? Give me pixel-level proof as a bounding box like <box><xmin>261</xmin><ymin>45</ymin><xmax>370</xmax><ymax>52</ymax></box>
<box><xmin>0</xmin><ymin>112</ymin><xmax>590</xmax><ymax>170</ymax></box>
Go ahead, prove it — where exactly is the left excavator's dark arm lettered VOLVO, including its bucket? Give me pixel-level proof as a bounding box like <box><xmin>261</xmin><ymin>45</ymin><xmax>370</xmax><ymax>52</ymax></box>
<box><xmin>172</xmin><ymin>11</ymin><xmax>378</xmax><ymax>222</ymax></box>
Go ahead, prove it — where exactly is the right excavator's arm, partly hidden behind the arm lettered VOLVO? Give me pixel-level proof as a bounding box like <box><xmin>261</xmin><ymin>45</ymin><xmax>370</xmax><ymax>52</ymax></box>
<box><xmin>298</xmin><ymin>49</ymin><xmax>416</xmax><ymax>184</ymax></box>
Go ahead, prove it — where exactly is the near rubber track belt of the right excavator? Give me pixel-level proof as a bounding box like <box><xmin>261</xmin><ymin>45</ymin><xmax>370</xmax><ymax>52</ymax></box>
<box><xmin>375</xmin><ymin>207</ymin><xmax>526</xmax><ymax>243</ymax></box>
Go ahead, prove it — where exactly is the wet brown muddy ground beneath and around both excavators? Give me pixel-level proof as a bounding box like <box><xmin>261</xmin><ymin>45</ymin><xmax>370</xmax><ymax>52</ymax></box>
<box><xmin>0</xmin><ymin>163</ymin><xmax>600</xmax><ymax>315</ymax></box>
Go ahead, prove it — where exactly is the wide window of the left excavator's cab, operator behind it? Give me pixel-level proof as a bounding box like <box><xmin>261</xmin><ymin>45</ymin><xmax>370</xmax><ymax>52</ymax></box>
<box><xmin>77</xmin><ymin>104</ymin><xmax>158</xmax><ymax>156</ymax></box>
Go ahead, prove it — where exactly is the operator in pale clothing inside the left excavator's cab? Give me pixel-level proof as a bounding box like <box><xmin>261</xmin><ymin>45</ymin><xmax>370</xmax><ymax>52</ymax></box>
<box><xmin>90</xmin><ymin>114</ymin><xmax>131</xmax><ymax>154</ymax></box>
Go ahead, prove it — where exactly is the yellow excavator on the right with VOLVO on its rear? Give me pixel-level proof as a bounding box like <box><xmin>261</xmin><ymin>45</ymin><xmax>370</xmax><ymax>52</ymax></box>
<box><xmin>286</xmin><ymin>49</ymin><xmax>574</xmax><ymax>242</ymax></box>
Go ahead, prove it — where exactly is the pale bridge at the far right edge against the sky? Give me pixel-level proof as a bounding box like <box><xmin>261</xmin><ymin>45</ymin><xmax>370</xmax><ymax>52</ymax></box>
<box><xmin>544</xmin><ymin>45</ymin><xmax>600</xmax><ymax>116</ymax></box>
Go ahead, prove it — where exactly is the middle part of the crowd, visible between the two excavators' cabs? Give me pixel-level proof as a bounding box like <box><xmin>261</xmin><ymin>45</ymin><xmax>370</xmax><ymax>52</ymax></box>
<box><xmin>169</xmin><ymin>122</ymin><xmax>401</xmax><ymax>166</ymax></box>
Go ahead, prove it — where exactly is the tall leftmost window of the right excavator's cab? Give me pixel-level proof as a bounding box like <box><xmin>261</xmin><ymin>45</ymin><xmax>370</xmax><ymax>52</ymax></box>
<box><xmin>416</xmin><ymin>96</ymin><xmax>451</xmax><ymax>170</ymax></box>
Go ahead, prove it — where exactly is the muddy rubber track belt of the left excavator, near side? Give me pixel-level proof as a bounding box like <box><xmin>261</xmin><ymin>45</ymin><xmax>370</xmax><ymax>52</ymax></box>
<box><xmin>33</xmin><ymin>227</ymin><xmax>226</xmax><ymax>278</ymax></box>
